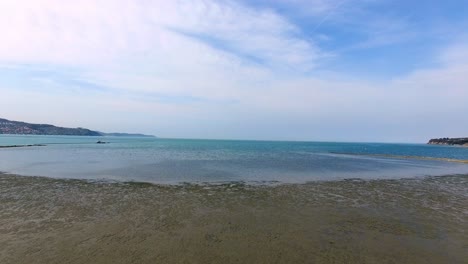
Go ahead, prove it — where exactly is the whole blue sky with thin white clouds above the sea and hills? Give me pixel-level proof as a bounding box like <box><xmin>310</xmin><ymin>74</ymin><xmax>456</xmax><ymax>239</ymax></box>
<box><xmin>0</xmin><ymin>0</ymin><xmax>468</xmax><ymax>143</ymax></box>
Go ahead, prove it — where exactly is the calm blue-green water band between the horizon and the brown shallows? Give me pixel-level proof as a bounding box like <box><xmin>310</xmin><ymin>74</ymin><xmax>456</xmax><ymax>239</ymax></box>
<box><xmin>0</xmin><ymin>135</ymin><xmax>468</xmax><ymax>184</ymax></box>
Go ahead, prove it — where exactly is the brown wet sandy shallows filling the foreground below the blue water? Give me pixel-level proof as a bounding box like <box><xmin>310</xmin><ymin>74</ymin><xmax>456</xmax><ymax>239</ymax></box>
<box><xmin>0</xmin><ymin>174</ymin><xmax>468</xmax><ymax>263</ymax></box>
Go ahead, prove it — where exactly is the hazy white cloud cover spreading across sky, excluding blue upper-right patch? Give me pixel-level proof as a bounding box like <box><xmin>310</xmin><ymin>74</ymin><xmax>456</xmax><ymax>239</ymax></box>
<box><xmin>0</xmin><ymin>0</ymin><xmax>468</xmax><ymax>140</ymax></box>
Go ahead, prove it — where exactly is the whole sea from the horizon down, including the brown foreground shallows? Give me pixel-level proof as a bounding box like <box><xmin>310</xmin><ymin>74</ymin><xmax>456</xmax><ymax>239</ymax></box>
<box><xmin>0</xmin><ymin>135</ymin><xmax>468</xmax><ymax>264</ymax></box>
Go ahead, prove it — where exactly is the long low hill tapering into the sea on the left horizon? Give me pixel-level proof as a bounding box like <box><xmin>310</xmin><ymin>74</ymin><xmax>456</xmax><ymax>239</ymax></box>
<box><xmin>0</xmin><ymin>118</ymin><xmax>153</xmax><ymax>137</ymax></box>
